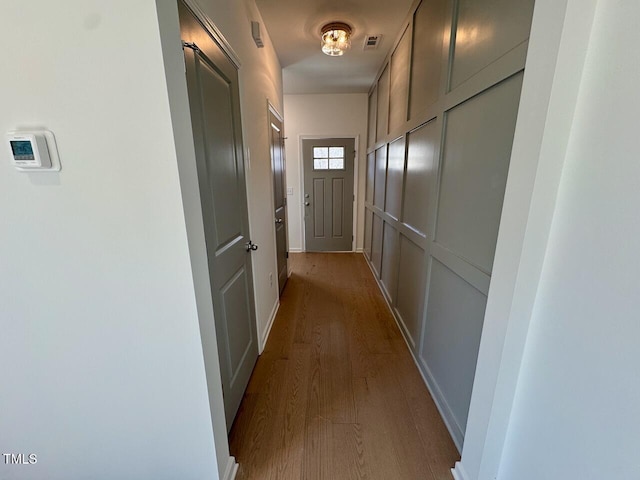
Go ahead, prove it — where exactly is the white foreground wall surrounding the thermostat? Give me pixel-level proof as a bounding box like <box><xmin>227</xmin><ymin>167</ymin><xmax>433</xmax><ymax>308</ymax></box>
<box><xmin>0</xmin><ymin>0</ymin><xmax>217</xmax><ymax>480</ymax></box>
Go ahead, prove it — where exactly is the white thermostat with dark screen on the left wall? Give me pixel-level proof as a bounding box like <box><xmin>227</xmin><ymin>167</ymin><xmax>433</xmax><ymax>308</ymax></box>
<box><xmin>7</xmin><ymin>130</ymin><xmax>60</xmax><ymax>171</ymax></box>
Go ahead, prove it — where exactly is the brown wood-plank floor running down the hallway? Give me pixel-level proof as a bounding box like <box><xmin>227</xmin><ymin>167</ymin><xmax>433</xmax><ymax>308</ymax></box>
<box><xmin>230</xmin><ymin>253</ymin><xmax>459</xmax><ymax>480</ymax></box>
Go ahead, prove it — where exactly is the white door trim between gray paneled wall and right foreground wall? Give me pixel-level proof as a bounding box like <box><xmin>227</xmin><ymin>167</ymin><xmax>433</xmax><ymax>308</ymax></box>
<box><xmin>452</xmin><ymin>0</ymin><xmax>597</xmax><ymax>480</ymax></box>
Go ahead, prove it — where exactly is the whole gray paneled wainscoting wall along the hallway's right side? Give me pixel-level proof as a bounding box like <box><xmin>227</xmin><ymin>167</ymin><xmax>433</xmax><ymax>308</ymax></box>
<box><xmin>364</xmin><ymin>0</ymin><xmax>534</xmax><ymax>449</ymax></box>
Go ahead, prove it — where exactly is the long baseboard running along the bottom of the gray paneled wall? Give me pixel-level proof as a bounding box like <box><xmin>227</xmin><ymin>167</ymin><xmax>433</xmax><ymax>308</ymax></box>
<box><xmin>364</xmin><ymin>255</ymin><xmax>466</xmax><ymax>454</ymax></box>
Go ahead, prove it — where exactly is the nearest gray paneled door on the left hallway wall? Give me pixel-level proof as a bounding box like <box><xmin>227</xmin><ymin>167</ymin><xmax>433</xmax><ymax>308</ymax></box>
<box><xmin>180</xmin><ymin>4</ymin><xmax>258</xmax><ymax>429</ymax></box>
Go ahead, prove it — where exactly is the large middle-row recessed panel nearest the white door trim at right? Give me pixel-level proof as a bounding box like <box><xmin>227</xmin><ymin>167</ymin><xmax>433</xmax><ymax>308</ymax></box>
<box><xmin>436</xmin><ymin>74</ymin><xmax>522</xmax><ymax>273</ymax></box>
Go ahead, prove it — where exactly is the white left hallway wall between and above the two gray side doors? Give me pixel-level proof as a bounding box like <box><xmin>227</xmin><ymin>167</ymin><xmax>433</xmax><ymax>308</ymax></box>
<box><xmin>188</xmin><ymin>0</ymin><xmax>287</xmax><ymax>349</ymax></box>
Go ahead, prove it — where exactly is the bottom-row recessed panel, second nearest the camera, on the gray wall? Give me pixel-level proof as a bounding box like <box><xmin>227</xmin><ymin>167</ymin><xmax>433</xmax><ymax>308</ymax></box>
<box><xmin>396</xmin><ymin>235</ymin><xmax>426</xmax><ymax>345</ymax></box>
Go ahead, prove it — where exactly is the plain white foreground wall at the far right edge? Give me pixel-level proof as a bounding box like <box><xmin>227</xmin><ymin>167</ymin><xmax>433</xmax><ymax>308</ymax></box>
<box><xmin>498</xmin><ymin>0</ymin><xmax>640</xmax><ymax>480</ymax></box>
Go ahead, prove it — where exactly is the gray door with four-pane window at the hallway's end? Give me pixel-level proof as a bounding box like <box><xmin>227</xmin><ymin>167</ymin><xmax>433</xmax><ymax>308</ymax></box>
<box><xmin>302</xmin><ymin>138</ymin><xmax>355</xmax><ymax>252</ymax></box>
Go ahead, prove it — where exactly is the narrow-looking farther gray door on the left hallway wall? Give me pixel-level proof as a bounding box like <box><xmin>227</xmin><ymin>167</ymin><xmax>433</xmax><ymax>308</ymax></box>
<box><xmin>269</xmin><ymin>108</ymin><xmax>289</xmax><ymax>293</ymax></box>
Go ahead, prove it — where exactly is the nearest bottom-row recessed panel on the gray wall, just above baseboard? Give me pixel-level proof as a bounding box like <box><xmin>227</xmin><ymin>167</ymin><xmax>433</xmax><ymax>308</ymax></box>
<box><xmin>421</xmin><ymin>259</ymin><xmax>487</xmax><ymax>432</ymax></box>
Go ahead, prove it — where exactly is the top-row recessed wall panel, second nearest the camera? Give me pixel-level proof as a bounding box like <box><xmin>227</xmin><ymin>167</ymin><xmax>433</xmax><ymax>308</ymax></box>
<box><xmin>409</xmin><ymin>0</ymin><xmax>452</xmax><ymax>119</ymax></box>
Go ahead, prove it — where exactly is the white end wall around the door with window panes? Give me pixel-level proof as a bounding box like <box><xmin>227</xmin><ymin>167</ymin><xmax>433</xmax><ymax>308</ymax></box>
<box><xmin>284</xmin><ymin>93</ymin><xmax>367</xmax><ymax>252</ymax></box>
